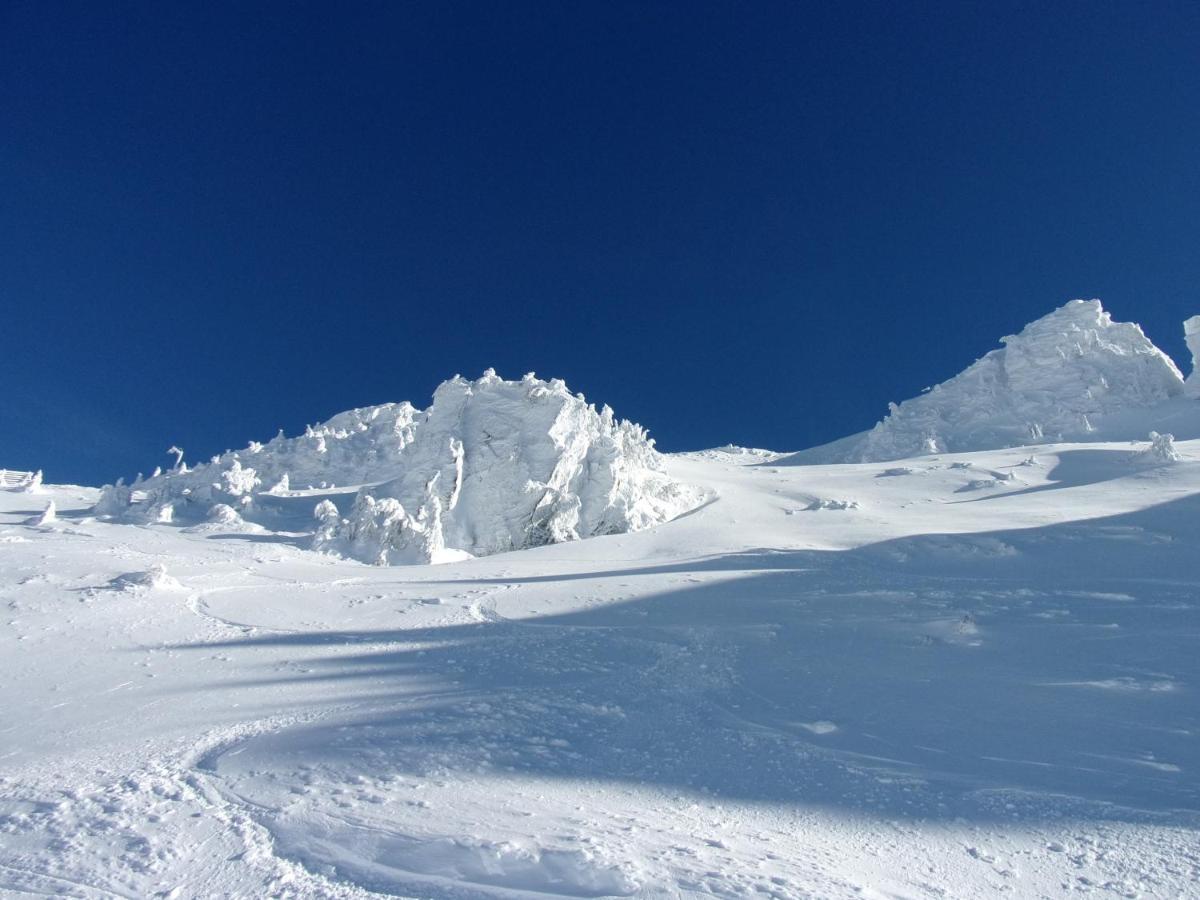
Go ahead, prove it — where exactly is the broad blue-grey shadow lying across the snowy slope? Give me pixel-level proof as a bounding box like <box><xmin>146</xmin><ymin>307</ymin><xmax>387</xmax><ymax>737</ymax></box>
<box><xmin>175</xmin><ymin>494</ymin><xmax>1200</xmax><ymax>822</ymax></box>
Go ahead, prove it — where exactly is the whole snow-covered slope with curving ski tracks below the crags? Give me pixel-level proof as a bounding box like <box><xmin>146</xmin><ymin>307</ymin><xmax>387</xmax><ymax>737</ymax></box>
<box><xmin>0</xmin><ymin>439</ymin><xmax>1200</xmax><ymax>900</ymax></box>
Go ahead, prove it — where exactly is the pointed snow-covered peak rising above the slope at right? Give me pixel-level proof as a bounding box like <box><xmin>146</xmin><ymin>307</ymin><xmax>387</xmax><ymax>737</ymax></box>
<box><xmin>790</xmin><ymin>300</ymin><xmax>1200</xmax><ymax>463</ymax></box>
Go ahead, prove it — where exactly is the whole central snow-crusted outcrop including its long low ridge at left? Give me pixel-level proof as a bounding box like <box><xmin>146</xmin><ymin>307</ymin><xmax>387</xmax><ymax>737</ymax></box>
<box><xmin>95</xmin><ymin>370</ymin><xmax>704</xmax><ymax>565</ymax></box>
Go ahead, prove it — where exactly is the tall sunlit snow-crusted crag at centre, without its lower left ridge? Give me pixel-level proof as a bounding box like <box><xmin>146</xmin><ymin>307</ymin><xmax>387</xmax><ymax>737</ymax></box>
<box><xmin>313</xmin><ymin>370</ymin><xmax>703</xmax><ymax>565</ymax></box>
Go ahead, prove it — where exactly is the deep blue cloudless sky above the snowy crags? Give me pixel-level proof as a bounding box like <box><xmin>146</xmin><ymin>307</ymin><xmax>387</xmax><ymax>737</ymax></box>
<box><xmin>0</xmin><ymin>0</ymin><xmax>1200</xmax><ymax>482</ymax></box>
